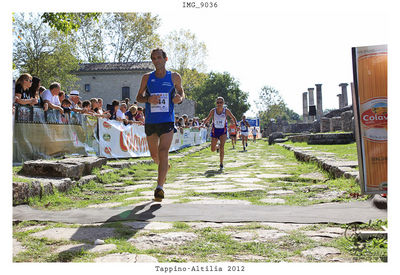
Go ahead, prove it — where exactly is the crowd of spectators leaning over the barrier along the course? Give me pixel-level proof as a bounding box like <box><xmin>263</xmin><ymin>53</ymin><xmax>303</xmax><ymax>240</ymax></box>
<box><xmin>13</xmin><ymin>73</ymin><xmax>209</xmax><ymax>131</ymax></box>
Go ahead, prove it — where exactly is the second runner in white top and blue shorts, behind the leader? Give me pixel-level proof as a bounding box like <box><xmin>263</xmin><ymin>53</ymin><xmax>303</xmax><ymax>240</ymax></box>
<box><xmin>203</xmin><ymin>96</ymin><xmax>236</xmax><ymax>169</ymax></box>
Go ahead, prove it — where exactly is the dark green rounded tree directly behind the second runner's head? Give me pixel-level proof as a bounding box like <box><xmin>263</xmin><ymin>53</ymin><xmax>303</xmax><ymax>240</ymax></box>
<box><xmin>192</xmin><ymin>72</ymin><xmax>250</xmax><ymax>118</ymax></box>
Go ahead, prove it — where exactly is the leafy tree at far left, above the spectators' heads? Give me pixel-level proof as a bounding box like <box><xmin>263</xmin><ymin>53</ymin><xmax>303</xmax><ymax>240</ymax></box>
<box><xmin>13</xmin><ymin>14</ymin><xmax>79</xmax><ymax>89</ymax></box>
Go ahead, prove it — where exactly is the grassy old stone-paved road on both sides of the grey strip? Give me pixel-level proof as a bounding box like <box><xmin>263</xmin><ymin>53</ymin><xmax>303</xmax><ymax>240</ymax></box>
<box><xmin>13</xmin><ymin>141</ymin><xmax>384</xmax><ymax>263</ymax></box>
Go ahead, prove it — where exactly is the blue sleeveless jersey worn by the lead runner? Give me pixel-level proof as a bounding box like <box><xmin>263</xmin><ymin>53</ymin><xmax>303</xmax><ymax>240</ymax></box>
<box><xmin>145</xmin><ymin>71</ymin><xmax>175</xmax><ymax>124</ymax></box>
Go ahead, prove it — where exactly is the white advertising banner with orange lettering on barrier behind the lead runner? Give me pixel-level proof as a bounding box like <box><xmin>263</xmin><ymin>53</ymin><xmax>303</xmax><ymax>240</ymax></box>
<box><xmin>99</xmin><ymin>118</ymin><xmax>207</xmax><ymax>158</ymax></box>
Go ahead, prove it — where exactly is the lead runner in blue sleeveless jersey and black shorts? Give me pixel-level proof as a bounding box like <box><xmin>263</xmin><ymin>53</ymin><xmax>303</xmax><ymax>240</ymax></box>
<box><xmin>136</xmin><ymin>48</ymin><xmax>185</xmax><ymax>201</ymax></box>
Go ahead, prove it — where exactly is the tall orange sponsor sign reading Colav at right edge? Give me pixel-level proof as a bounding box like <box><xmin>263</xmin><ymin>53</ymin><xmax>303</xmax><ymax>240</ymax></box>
<box><xmin>352</xmin><ymin>45</ymin><xmax>388</xmax><ymax>194</ymax></box>
